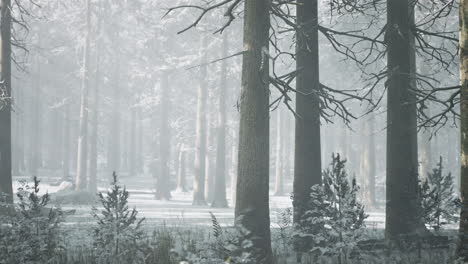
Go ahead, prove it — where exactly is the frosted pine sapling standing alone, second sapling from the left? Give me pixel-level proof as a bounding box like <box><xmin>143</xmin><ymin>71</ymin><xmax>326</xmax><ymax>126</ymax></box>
<box><xmin>93</xmin><ymin>172</ymin><xmax>145</xmax><ymax>263</ymax></box>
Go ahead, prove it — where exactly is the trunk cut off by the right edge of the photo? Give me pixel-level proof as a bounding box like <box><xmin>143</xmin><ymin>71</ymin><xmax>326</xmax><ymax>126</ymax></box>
<box><xmin>458</xmin><ymin>0</ymin><xmax>468</xmax><ymax>261</ymax></box>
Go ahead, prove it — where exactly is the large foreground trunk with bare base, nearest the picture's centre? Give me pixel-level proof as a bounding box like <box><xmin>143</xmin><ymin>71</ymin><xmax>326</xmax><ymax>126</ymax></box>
<box><xmin>235</xmin><ymin>0</ymin><xmax>274</xmax><ymax>264</ymax></box>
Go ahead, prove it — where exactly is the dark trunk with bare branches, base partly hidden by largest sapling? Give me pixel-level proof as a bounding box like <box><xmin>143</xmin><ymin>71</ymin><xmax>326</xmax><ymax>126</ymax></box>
<box><xmin>293</xmin><ymin>0</ymin><xmax>322</xmax><ymax>231</ymax></box>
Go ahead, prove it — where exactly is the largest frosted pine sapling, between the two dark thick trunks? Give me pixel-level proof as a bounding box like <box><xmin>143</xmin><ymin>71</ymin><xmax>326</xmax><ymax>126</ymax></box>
<box><xmin>294</xmin><ymin>154</ymin><xmax>367</xmax><ymax>264</ymax></box>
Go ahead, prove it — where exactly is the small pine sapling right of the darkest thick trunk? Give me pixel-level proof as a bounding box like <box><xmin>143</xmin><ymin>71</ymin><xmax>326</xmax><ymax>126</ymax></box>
<box><xmin>419</xmin><ymin>157</ymin><xmax>459</xmax><ymax>231</ymax></box>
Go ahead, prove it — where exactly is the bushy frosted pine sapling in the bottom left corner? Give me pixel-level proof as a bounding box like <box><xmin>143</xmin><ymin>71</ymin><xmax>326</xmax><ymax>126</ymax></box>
<box><xmin>0</xmin><ymin>177</ymin><xmax>63</xmax><ymax>263</ymax></box>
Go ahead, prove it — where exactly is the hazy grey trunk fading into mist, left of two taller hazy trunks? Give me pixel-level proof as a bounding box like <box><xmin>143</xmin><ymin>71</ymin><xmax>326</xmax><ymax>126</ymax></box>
<box><xmin>156</xmin><ymin>73</ymin><xmax>171</xmax><ymax>200</ymax></box>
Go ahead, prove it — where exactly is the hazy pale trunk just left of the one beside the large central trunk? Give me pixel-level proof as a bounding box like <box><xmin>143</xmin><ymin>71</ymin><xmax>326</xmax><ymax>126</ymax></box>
<box><xmin>193</xmin><ymin>36</ymin><xmax>208</xmax><ymax>205</ymax></box>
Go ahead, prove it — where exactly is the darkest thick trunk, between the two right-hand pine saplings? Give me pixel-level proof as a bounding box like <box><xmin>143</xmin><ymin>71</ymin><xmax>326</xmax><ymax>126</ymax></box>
<box><xmin>385</xmin><ymin>0</ymin><xmax>425</xmax><ymax>239</ymax></box>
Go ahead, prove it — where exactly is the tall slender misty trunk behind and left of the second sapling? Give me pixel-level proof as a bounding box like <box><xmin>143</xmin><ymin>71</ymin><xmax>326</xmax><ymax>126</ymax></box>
<box><xmin>76</xmin><ymin>0</ymin><xmax>91</xmax><ymax>190</ymax></box>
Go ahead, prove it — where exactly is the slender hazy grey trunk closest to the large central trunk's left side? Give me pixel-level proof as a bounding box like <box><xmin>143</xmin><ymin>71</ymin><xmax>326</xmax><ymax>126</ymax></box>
<box><xmin>211</xmin><ymin>32</ymin><xmax>229</xmax><ymax>208</ymax></box>
